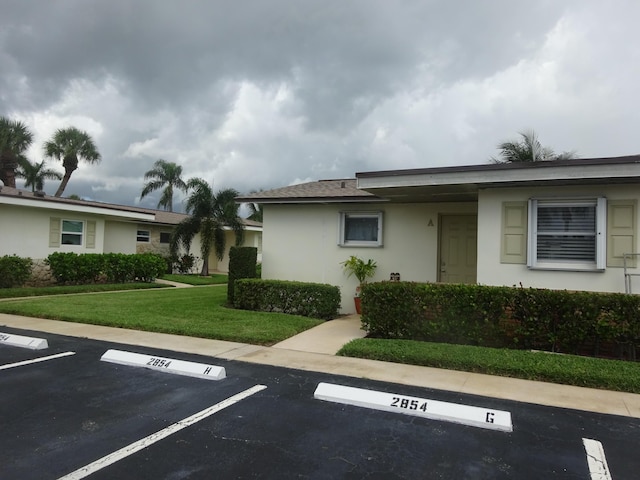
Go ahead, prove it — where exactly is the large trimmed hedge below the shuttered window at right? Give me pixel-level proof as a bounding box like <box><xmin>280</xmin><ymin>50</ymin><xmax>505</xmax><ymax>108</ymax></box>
<box><xmin>362</xmin><ymin>282</ymin><xmax>640</xmax><ymax>360</ymax></box>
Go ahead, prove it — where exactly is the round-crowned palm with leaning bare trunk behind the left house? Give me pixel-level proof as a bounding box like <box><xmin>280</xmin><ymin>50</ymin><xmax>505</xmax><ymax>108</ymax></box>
<box><xmin>44</xmin><ymin>127</ymin><xmax>102</xmax><ymax>197</ymax></box>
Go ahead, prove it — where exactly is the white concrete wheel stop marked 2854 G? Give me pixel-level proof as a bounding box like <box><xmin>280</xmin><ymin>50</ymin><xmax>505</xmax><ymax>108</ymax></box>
<box><xmin>314</xmin><ymin>383</ymin><xmax>513</xmax><ymax>432</ymax></box>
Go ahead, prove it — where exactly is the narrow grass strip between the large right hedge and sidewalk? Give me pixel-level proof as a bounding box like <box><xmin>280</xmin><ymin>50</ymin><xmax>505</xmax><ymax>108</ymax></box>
<box><xmin>338</xmin><ymin>338</ymin><xmax>640</xmax><ymax>393</ymax></box>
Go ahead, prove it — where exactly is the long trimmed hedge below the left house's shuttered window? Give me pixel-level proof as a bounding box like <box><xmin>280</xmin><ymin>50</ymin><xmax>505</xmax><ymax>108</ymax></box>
<box><xmin>45</xmin><ymin>252</ymin><xmax>167</xmax><ymax>285</ymax></box>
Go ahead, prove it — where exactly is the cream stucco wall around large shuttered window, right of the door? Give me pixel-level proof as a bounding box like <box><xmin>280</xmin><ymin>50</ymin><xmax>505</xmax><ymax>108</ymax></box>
<box><xmin>478</xmin><ymin>185</ymin><xmax>640</xmax><ymax>292</ymax></box>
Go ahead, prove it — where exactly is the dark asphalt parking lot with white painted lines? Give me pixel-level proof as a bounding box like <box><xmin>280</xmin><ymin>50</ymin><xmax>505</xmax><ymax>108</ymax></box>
<box><xmin>0</xmin><ymin>328</ymin><xmax>640</xmax><ymax>480</ymax></box>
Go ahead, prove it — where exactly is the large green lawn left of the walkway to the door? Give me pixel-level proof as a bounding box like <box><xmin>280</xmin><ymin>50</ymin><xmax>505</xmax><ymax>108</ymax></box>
<box><xmin>0</xmin><ymin>287</ymin><xmax>322</xmax><ymax>345</ymax></box>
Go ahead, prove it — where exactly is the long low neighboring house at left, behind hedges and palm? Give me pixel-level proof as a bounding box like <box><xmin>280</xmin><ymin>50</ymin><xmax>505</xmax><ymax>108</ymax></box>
<box><xmin>0</xmin><ymin>186</ymin><xmax>262</xmax><ymax>278</ymax></box>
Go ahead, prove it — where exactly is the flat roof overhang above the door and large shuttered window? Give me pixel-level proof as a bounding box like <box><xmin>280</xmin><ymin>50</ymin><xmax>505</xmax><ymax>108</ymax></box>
<box><xmin>356</xmin><ymin>156</ymin><xmax>640</xmax><ymax>202</ymax></box>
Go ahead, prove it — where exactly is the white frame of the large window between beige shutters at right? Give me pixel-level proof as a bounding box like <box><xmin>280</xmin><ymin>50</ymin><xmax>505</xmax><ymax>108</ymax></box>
<box><xmin>527</xmin><ymin>197</ymin><xmax>607</xmax><ymax>271</ymax></box>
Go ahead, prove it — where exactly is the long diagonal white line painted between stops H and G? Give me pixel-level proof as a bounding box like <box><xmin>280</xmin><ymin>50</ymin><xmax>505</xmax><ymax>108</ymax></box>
<box><xmin>58</xmin><ymin>385</ymin><xmax>267</xmax><ymax>480</ymax></box>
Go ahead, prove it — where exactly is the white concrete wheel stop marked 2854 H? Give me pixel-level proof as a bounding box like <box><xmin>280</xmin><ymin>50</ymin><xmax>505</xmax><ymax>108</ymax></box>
<box><xmin>100</xmin><ymin>350</ymin><xmax>226</xmax><ymax>380</ymax></box>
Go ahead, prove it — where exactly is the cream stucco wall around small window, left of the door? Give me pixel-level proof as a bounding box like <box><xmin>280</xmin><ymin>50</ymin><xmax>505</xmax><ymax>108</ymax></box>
<box><xmin>262</xmin><ymin>203</ymin><xmax>476</xmax><ymax>313</ymax></box>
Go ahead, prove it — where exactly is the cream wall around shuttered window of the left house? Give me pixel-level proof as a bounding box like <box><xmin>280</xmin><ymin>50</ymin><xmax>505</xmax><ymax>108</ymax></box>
<box><xmin>0</xmin><ymin>205</ymin><xmax>105</xmax><ymax>259</ymax></box>
